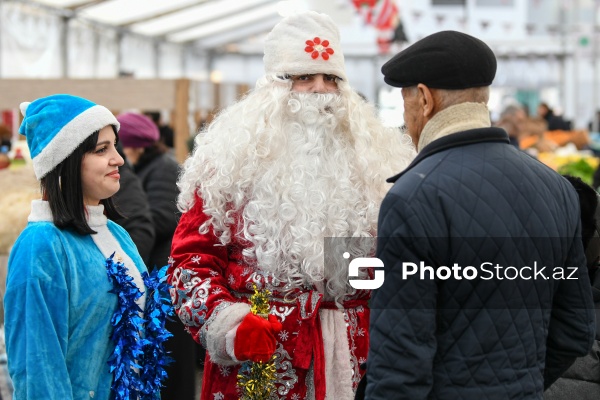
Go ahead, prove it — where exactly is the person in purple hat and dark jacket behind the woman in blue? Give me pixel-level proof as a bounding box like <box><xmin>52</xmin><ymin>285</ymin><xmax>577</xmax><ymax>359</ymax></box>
<box><xmin>117</xmin><ymin>112</ymin><xmax>196</xmax><ymax>400</ymax></box>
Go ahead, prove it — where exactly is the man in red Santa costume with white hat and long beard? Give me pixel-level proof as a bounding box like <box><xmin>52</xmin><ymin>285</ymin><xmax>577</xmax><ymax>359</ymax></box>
<box><xmin>169</xmin><ymin>12</ymin><xmax>414</xmax><ymax>400</ymax></box>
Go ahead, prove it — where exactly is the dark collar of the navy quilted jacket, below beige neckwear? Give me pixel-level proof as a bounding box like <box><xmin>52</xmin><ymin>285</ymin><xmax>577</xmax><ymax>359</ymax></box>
<box><xmin>387</xmin><ymin>128</ymin><xmax>510</xmax><ymax>183</ymax></box>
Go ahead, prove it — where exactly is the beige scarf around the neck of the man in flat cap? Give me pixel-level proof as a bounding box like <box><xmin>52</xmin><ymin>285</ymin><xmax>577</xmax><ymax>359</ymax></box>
<box><xmin>417</xmin><ymin>103</ymin><xmax>492</xmax><ymax>151</ymax></box>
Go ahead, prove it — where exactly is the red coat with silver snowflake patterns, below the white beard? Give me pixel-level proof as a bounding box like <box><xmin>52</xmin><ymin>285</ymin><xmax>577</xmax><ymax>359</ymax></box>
<box><xmin>168</xmin><ymin>197</ymin><xmax>370</xmax><ymax>400</ymax></box>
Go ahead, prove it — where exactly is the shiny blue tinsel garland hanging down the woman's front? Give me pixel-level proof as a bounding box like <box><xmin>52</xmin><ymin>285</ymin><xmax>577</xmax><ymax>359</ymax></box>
<box><xmin>106</xmin><ymin>253</ymin><xmax>173</xmax><ymax>400</ymax></box>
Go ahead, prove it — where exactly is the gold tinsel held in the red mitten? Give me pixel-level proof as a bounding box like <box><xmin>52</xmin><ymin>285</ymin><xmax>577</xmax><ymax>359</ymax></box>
<box><xmin>237</xmin><ymin>285</ymin><xmax>276</xmax><ymax>400</ymax></box>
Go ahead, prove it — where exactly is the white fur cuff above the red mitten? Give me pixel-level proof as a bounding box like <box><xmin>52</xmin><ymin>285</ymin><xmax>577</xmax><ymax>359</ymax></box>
<box><xmin>206</xmin><ymin>303</ymin><xmax>250</xmax><ymax>365</ymax></box>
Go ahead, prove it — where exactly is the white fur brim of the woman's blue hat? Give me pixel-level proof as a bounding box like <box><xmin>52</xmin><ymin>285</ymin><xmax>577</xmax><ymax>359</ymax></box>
<box><xmin>33</xmin><ymin>105</ymin><xmax>120</xmax><ymax>179</ymax></box>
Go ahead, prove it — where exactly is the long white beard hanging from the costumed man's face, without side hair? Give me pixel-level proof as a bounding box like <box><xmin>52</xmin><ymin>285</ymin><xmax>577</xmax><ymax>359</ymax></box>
<box><xmin>242</xmin><ymin>93</ymin><xmax>379</xmax><ymax>295</ymax></box>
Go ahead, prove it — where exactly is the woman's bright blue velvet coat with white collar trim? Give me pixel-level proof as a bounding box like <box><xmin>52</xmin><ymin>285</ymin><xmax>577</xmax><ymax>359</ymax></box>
<box><xmin>4</xmin><ymin>201</ymin><xmax>146</xmax><ymax>400</ymax></box>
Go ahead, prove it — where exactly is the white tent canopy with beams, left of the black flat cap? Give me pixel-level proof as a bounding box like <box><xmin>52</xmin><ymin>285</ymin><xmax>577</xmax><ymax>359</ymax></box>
<box><xmin>0</xmin><ymin>0</ymin><xmax>390</xmax><ymax>99</ymax></box>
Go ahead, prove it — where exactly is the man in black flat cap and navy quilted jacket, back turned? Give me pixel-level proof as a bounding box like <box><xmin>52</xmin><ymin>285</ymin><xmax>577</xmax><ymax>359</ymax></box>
<box><xmin>366</xmin><ymin>31</ymin><xmax>594</xmax><ymax>400</ymax></box>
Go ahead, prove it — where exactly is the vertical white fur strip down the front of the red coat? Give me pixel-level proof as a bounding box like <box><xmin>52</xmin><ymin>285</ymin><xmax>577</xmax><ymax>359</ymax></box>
<box><xmin>319</xmin><ymin>310</ymin><xmax>354</xmax><ymax>400</ymax></box>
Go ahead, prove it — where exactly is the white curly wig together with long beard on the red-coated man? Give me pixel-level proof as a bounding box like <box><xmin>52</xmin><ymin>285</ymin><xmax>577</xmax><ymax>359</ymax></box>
<box><xmin>178</xmin><ymin>75</ymin><xmax>415</xmax><ymax>300</ymax></box>
